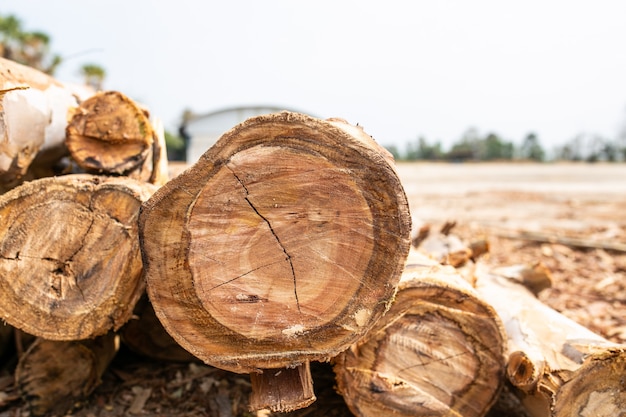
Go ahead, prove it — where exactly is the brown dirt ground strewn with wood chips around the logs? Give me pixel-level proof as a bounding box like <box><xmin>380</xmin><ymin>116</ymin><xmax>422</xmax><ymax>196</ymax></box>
<box><xmin>0</xmin><ymin>163</ymin><xmax>626</xmax><ymax>417</ymax></box>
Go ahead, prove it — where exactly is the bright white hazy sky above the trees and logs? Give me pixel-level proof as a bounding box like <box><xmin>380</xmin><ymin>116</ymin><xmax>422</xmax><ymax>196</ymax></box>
<box><xmin>0</xmin><ymin>0</ymin><xmax>626</xmax><ymax>149</ymax></box>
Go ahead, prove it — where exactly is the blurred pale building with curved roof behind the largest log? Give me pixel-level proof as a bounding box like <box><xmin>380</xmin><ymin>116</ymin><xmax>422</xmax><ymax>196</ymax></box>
<box><xmin>182</xmin><ymin>106</ymin><xmax>310</xmax><ymax>164</ymax></box>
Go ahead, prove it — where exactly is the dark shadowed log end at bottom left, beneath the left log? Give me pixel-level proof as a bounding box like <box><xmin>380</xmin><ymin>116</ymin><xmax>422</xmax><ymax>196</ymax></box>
<box><xmin>15</xmin><ymin>333</ymin><xmax>119</xmax><ymax>416</ymax></box>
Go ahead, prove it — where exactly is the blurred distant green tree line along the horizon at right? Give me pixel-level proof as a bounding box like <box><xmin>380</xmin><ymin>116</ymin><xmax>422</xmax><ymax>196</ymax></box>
<box><xmin>387</xmin><ymin>128</ymin><xmax>626</xmax><ymax>162</ymax></box>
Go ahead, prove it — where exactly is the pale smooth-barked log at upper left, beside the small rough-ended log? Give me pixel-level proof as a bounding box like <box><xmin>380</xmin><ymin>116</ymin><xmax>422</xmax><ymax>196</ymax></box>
<box><xmin>0</xmin><ymin>58</ymin><xmax>84</xmax><ymax>189</ymax></box>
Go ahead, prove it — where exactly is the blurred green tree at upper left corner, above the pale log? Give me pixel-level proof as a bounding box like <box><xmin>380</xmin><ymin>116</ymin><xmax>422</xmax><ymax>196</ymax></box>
<box><xmin>0</xmin><ymin>15</ymin><xmax>61</xmax><ymax>74</ymax></box>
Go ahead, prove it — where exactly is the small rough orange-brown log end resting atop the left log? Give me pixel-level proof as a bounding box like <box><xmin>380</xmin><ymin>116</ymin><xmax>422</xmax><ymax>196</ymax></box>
<box><xmin>65</xmin><ymin>91</ymin><xmax>167</xmax><ymax>185</ymax></box>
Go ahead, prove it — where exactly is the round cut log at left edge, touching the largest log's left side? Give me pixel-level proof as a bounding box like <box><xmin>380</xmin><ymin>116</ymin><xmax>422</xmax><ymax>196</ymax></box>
<box><xmin>0</xmin><ymin>174</ymin><xmax>156</xmax><ymax>340</ymax></box>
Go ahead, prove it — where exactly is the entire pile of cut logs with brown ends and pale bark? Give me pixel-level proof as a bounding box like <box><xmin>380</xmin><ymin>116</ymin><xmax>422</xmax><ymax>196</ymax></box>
<box><xmin>0</xmin><ymin>56</ymin><xmax>626</xmax><ymax>417</ymax></box>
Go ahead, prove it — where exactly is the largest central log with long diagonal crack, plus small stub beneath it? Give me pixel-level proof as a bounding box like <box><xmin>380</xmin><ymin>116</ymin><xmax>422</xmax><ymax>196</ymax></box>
<box><xmin>139</xmin><ymin>112</ymin><xmax>411</xmax><ymax>410</ymax></box>
